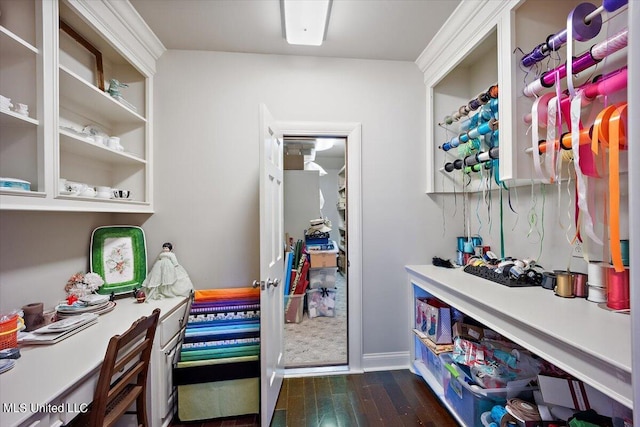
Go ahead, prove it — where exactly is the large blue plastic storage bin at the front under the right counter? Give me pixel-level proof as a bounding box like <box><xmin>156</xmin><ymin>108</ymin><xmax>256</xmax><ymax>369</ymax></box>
<box><xmin>440</xmin><ymin>353</ymin><xmax>537</xmax><ymax>427</ymax></box>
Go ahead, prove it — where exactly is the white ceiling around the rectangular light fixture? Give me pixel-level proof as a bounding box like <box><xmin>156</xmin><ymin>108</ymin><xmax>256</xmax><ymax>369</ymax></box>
<box><xmin>130</xmin><ymin>0</ymin><xmax>459</xmax><ymax>61</ymax></box>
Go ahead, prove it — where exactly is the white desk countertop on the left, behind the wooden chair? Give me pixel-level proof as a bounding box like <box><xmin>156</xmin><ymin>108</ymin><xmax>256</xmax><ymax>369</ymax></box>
<box><xmin>0</xmin><ymin>298</ymin><xmax>185</xmax><ymax>427</ymax></box>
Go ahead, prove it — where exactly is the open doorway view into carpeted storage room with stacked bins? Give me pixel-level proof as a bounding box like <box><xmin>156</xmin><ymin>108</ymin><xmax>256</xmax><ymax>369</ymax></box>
<box><xmin>283</xmin><ymin>134</ymin><xmax>349</xmax><ymax>369</ymax></box>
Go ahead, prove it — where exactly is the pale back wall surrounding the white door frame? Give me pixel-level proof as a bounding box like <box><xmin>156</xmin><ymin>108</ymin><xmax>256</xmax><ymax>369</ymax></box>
<box><xmin>144</xmin><ymin>51</ymin><xmax>438</xmax><ymax>353</ymax></box>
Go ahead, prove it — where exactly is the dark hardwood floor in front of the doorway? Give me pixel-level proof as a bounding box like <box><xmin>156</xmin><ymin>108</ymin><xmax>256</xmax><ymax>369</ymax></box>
<box><xmin>172</xmin><ymin>370</ymin><xmax>458</xmax><ymax>427</ymax></box>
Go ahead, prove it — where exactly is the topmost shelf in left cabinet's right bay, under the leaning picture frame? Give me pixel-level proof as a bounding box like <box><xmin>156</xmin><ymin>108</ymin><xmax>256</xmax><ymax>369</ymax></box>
<box><xmin>59</xmin><ymin>65</ymin><xmax>147</xmax><ymax>125</ymax></box>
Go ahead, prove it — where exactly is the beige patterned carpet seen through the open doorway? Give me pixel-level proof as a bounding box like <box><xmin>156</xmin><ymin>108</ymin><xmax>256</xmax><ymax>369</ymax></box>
<box><xmin>284</xmin><ymin>273</ymin><xmax>348</xmax><ymax>368</ymax></box>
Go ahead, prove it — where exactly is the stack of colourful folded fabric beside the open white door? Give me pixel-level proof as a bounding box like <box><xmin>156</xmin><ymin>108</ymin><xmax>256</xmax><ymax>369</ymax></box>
<box><xmin>173</xmin><ymin>288</ymin><xmax>260</xmax><ymax>421</ymax></box>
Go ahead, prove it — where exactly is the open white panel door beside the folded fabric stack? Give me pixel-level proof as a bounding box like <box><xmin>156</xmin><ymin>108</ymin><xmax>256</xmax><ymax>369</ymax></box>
<box><xmin>259</xmin><ymin>105</ymin><xmax>284</xmax><ymax>427</ymax></box>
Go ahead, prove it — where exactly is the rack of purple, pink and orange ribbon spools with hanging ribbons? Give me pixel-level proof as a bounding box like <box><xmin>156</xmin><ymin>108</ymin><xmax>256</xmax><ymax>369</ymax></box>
<box><xmin>519</xmin><ymin>0</ymin><xmax>629</xmax><ymax>272</ymax></box>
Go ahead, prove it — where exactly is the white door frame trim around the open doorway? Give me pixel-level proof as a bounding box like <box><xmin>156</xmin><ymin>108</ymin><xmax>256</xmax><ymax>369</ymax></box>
<box><xmin>279</xmin><ymin>122</ymin><xmax>363</xmax><ymax>377</ymax></box>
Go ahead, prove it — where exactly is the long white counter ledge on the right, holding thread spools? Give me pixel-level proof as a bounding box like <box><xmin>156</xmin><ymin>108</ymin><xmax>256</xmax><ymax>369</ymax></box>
<box><xmin>405</xmin><ymin>265</ymin><xmax>633</xmax><ymax>408</ymax></box>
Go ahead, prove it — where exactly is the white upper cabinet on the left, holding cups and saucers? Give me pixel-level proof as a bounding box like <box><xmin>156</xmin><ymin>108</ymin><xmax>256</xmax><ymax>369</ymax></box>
<box><xmin>0</xmin><ymin>0</ymin><xmax>164</xmax><ymax>212</ymax></box>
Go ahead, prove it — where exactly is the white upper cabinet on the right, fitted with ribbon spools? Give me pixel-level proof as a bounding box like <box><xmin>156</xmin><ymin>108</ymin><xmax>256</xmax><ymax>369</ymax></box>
<box><xmin>416</xmin><ymin>0</ymin><xmax>628</xmax><ymax>193</ymax></box>
